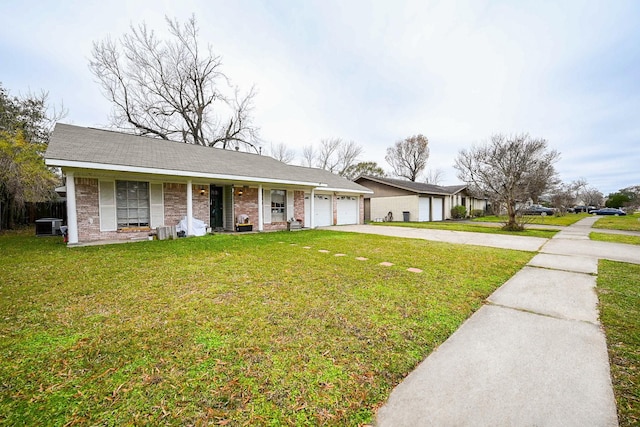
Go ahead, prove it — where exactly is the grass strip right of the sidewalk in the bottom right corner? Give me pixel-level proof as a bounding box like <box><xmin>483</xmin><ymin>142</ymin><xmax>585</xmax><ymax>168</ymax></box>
<box><xmin>598</xmin><ymin>260</ymin><xmax>640</xmax><ymax>427</ymax></box>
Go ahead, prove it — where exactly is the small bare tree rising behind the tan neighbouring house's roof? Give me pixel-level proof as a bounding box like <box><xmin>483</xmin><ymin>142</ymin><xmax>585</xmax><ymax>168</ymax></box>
<box><xmin>384</xmin><ymin>135</ymin><xmax>429</xmax><ymax>182</ymax></box>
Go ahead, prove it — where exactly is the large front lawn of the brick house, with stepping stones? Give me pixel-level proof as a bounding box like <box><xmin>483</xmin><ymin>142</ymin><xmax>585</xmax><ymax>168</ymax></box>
<box><xmin>0</xmin><ymin>231</ymin><xmax>533</xmax><ymax>426</ymax></box>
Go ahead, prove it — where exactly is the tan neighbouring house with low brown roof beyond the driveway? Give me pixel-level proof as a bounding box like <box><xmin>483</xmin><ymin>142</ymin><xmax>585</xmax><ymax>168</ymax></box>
<box><xmin>355</xmin><ymin>175</ymin><xmax>486</xmax><ymax>221</ymax></box>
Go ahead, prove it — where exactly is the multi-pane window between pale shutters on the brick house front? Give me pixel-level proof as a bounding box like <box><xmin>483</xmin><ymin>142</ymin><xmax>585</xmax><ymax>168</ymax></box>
<box><xmin>116</xmin><ymin>181</ymin><xmax>149</xmax><ymax>228</ymax></box>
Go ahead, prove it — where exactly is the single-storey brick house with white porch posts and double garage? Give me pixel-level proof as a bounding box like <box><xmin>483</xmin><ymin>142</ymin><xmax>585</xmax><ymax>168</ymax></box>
<box><xmin>45</xmin><ymin>123</ymin><xmax>370</xmax><ymax>244</ymax></box>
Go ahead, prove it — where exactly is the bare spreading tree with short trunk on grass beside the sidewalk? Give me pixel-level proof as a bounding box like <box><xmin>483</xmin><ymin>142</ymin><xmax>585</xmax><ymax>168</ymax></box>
<box><xmin>454</xmin><ymin>134</ymin><xmax>560</xmax><ymax>230</ymax></box>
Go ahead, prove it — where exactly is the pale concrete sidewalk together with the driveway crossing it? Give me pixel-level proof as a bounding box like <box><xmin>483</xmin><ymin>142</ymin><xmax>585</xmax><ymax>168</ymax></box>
<box><xmin>333</xmin><ymin>217</ymin><xmax>640</xmax><ymax>427</ymax></box>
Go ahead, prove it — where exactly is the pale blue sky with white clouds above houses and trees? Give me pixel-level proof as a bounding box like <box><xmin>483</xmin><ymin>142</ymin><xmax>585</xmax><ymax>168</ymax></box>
<box><xmin>0</xmin><ymin>0</ymin><xmax>640</xmax><ymax>195</ymax></box>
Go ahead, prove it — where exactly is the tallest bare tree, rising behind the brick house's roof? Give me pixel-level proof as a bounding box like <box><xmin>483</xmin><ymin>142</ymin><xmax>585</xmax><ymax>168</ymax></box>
<box><xmin>89</xmin><ymin>16</ymin><xmax>257</xmax><ymax>151</ymax></box>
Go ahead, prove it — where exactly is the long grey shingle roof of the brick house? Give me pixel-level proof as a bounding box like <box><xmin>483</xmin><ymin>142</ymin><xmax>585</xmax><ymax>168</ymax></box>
<box><xmin>45</xmin><ymin>123</ymin><xmax>369</xmax><ymax>193</ymax></box>
